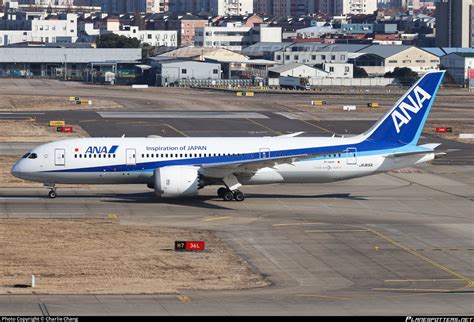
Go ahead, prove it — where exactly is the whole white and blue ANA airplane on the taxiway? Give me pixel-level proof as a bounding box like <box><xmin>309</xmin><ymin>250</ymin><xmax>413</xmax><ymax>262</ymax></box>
<box><xmin>11</xmin><ymin>71</ymin><xmax>444</xmax><ymax>201</ymax></box>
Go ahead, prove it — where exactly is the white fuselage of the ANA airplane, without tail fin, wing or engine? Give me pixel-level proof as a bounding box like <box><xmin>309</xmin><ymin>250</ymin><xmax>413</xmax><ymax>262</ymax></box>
<box><xmin>12</xmin><ymin>136</ymin><xmax>434</xmax><ymax>185</ymax></box>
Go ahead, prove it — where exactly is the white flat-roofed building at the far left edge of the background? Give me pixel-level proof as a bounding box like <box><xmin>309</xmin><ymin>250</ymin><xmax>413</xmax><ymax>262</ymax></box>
<box><xmin>0</xmin><ymin>14</ymin><xmax>77</xmax><ymax>46</ymax></box>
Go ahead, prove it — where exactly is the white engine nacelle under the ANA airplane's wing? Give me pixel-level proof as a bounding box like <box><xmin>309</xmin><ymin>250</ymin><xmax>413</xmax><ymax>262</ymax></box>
<box><xmin>153</xmin><ymin>166</ymin><xmax>202</xmax><ymax>198</ymax></box>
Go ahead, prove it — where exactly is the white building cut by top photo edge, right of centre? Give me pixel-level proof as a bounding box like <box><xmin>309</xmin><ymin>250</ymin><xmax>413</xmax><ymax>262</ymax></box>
<box><xmin>319</xmin><ymin>0</ymin><xmax>377</xmax><ymax>16</ymax></box>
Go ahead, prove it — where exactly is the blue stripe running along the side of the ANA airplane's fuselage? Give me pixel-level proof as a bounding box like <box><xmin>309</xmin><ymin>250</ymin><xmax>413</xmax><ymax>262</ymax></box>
<box><xmin>45</xmin><ymin>141</ymin><xmax>432</xmax><ymax>173</ymax></box>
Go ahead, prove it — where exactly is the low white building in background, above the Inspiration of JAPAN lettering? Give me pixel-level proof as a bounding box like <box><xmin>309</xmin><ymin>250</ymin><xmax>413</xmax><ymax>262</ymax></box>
<box><xmin>109</xmin><ymin>26</ymin><xmax>178</xmax><ymax>47</ymax></box>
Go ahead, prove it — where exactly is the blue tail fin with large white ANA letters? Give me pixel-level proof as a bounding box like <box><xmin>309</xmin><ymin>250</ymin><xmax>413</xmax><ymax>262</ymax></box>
<box><xmin>363</xmin><ymin>71</ymin><xmax>444</xmax><ymax>145</ymax></box>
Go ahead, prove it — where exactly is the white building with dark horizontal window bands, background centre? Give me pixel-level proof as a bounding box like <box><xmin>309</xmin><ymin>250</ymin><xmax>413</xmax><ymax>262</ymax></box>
<box><xmin>194</xmin><ymin>23</ymin><xmax>282</xmax><ymax>51</ymax></box>
